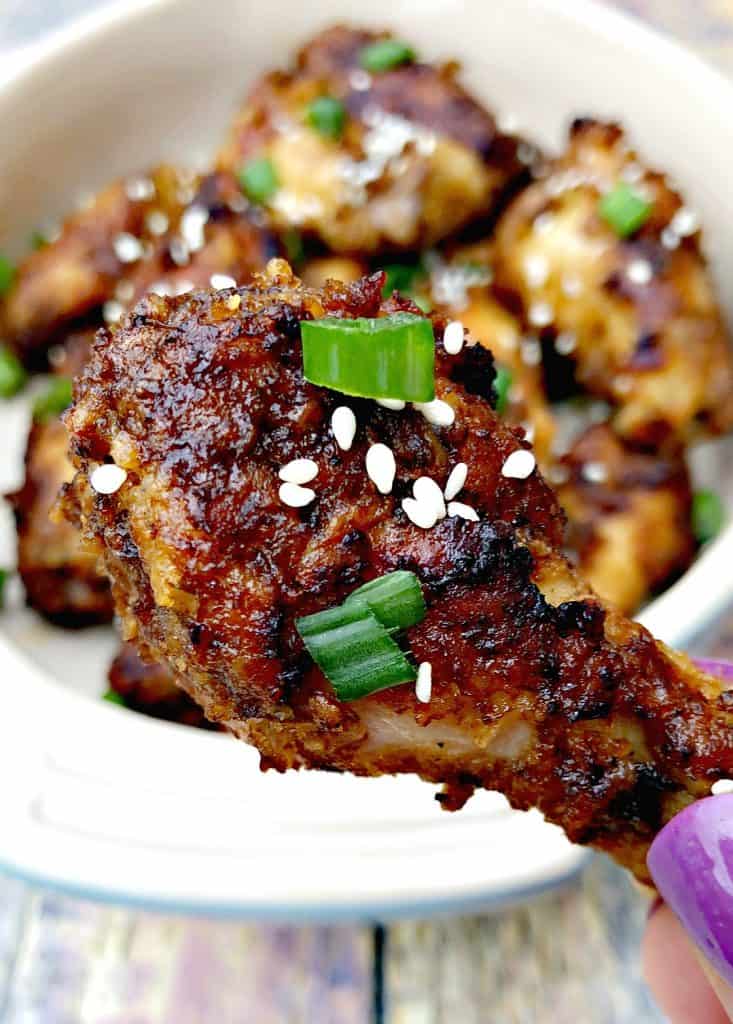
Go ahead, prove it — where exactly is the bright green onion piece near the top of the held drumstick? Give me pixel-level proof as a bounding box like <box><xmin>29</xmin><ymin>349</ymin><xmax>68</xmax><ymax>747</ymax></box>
<box><xmin>300</xmin><ymin>313</ymin><xmax>435</xmax><ymax>401</ymax></box>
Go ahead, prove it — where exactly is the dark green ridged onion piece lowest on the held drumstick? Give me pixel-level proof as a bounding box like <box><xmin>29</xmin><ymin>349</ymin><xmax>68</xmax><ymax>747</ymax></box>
<box><xmin>295</xmin><ymin>601</ymin><xmax>417</xmax><ymax>700</ymax></box>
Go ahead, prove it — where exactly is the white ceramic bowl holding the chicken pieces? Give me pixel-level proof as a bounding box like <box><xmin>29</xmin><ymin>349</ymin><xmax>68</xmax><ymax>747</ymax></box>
<box><xmin>0</xmin><ymin>0</ymin><xmax>733</xmax><ymax>919</ymax></box>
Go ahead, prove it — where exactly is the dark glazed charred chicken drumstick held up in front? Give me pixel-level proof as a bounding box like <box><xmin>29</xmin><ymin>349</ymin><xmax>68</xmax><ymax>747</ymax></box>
<box><xmin>66</xmin><ymin>262</ymin><xmax>733</xmax><ymax>880</ymax></box>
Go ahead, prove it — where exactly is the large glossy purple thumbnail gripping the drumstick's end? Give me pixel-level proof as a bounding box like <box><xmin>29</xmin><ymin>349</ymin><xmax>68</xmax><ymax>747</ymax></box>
<box><xmin>647</xmin><ymin>793</ymin><xmax>733</xmax><ymax>985</ymax></box>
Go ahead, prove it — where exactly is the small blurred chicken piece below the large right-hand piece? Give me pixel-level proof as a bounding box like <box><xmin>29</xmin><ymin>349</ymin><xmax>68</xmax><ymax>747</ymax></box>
<box><xmin>557</xmin><ymin>425</ymin><xmax>696</xmax><ymax>612</ymax></box>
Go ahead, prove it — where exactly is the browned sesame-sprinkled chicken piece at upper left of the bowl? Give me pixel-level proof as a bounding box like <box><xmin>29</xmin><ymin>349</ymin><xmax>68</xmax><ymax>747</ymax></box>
<box><xmin>0</xmin><ymin>166</ymin><xmax>277</xmax><ymax>368</ymax></box>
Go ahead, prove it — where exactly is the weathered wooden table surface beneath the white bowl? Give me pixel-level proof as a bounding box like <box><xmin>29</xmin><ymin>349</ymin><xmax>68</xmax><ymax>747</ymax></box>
<box><xmin>0</xmin><ymin>0</ymin><xmax>733</xmax><ymax>1024</ymax></box>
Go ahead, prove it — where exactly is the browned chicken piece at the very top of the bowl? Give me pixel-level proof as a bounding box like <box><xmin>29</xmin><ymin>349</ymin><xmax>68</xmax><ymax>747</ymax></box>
<box><xmin>218</xmin><ymin>27</ymin><xmax>526</xmax><ymax>253</ymax></box>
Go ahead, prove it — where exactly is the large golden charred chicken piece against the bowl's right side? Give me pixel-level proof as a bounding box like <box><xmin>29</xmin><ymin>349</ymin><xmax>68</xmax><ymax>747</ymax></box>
<box><xmin>497</xmin><ymin>120</ymin><xmax>733</xmax><ymax>446</ymax></box>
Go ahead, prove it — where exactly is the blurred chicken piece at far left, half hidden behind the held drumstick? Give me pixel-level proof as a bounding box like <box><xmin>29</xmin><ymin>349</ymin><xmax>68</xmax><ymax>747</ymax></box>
<box><xmin>7</xmin><ymin>332</ymin><xmax>114</xmax><ymax>629</ymax></box>
